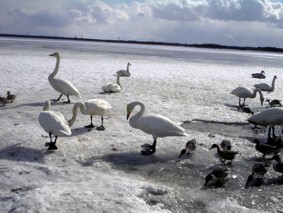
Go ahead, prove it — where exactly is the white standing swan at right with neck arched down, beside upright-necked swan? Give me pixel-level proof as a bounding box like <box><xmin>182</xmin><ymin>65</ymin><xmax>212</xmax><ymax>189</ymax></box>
<box><xmin>230</xmin><ymin>87</ymin><xmax>264</xmax><ymax>106</ymax></box>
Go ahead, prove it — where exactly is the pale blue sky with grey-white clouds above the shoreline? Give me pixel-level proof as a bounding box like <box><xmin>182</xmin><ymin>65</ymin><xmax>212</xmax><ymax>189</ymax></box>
<box><xmin>0</xmin><ymin>0</ymin><xmax>283</xmax><ymax>48</ymax></box>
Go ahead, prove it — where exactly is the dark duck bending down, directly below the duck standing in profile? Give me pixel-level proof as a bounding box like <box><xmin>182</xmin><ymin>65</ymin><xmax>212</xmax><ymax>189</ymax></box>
<box><xmin>204</xmin><ymin>166</ymin><xmax>231</xmax><ymax>187</ymax></box>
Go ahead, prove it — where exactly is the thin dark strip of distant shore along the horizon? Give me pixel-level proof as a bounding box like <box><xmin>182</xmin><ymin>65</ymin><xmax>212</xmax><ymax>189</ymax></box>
<box><xmin>0</xmin><ymin>33</ymin><xmax>283</xmax><ymax>53</ymax></box>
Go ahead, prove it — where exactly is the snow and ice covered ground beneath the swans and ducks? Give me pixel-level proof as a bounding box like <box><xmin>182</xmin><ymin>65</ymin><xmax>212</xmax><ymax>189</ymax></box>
<box><xmin>0</xmin><ymin>38</ymin><xmax>283</xmax><ymax>212</ymax></box>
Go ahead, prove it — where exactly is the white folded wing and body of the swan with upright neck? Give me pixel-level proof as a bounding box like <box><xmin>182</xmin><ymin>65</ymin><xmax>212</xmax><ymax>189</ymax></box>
<box><xmin>48</xmin><ymin>78</ymin><xmax>81</xmax><ymax>98</ymax></box>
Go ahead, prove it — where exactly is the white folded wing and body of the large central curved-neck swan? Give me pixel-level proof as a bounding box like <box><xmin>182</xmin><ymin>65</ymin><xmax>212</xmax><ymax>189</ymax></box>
<box><xmin>130</xmin><ymin>114</ymin><xmax>186</xmax><ymax>137</ymax></box>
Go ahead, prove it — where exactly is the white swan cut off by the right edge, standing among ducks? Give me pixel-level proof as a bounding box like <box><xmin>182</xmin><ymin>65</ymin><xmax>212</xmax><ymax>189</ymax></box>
<box><xmin>248</xmin><ymin>108</ymin><xmax>283</xmax><ymax>138</ymax></box>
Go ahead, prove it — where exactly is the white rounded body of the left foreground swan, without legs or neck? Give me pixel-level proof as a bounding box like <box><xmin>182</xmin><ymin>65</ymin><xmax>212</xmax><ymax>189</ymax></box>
<box><xmin>38</xmin><ymin>111</ymin><xmax>72</xmax><ymax>136</ymax></box>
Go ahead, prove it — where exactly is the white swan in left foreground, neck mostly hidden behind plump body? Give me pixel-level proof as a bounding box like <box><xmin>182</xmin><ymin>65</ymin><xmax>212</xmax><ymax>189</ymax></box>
<box><xmin>38</xmin><ymin>101</ymin><xmax>72</xmax><ymax>150</ymax></box>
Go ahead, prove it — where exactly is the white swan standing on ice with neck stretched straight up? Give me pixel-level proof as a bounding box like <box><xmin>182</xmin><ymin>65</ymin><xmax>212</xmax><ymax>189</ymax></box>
<box><xmin>48</xmin><ymin>52</ymin><xmax>81</xmax><ymax>103</ymax></box>
